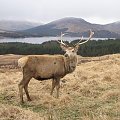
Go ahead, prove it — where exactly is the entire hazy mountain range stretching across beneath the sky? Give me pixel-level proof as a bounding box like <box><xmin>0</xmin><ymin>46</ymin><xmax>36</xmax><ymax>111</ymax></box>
<box><xmin>0</xmin><ymin>17</ymin><xmax>120</xmax><ymax>38</ymax></box>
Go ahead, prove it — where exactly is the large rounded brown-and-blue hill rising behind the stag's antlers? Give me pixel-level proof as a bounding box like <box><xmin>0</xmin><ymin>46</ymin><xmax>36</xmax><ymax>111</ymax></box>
<box><xmin>23</xmin><ymin>17</ymin><xmax>120</xmax><ymax>38</ymax></box>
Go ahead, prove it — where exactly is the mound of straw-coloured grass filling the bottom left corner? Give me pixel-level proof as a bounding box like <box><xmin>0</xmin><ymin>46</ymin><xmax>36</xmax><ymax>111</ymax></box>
<box><xmin>0</xmin><ymin>103</ymin><xmax>44</xmax><ymax>120</ymax></box>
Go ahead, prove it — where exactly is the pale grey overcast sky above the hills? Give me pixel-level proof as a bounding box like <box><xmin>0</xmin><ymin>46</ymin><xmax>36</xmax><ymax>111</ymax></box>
<box><xmin>0</xmin><ymin>0</ymin><xmax>120</xmax><ymax>24</ymax></box>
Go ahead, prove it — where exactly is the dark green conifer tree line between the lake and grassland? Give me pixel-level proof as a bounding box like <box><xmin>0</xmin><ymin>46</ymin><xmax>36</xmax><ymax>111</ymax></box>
<box><xmin>0</xmin><ymin>39</ymin><xmax>120</xmax><ymax>57</ymax></box>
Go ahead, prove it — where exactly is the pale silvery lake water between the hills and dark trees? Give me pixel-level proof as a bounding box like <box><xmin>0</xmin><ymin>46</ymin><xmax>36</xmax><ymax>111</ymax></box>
<box><xmin>0</xmin><ymin>37</ymin><xmax>107</xmax><ymax>44</ymax></box>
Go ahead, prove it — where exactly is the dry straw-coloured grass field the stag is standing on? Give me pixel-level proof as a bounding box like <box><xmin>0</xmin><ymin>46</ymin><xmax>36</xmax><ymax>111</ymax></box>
<box><xmin>0</xmin><ymin>54</ymin><xmax>120</xmax><ymax>120</ymax></box>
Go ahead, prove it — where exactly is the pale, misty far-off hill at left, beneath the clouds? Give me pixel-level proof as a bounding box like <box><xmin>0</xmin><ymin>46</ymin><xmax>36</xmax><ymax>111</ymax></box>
<box><xmin>0</xmin><ymin>20</ymin><xmax>42</xmax><ymax>31</ymax></box>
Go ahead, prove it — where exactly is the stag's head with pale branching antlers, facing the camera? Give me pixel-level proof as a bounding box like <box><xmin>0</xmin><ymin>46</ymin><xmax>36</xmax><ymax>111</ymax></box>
<box><xmin>58</xmin><ymin>30</ymin><xmax>94</xmax><ymax>58</ymax></box>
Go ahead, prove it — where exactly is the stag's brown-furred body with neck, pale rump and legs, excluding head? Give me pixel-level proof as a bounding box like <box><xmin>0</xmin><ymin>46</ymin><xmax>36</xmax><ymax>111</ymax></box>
<box><xmin>18</xmin><ymin>55</ymin><xmax>77</xmax><ymax>102</ymax></box>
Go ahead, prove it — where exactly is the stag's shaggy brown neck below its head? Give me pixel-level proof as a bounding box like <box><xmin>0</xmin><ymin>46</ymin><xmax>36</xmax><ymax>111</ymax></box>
<box><xmin>65</xmin><ymin>56</ymin><xmax>77</xmax><ymax>74</ymax></box>
